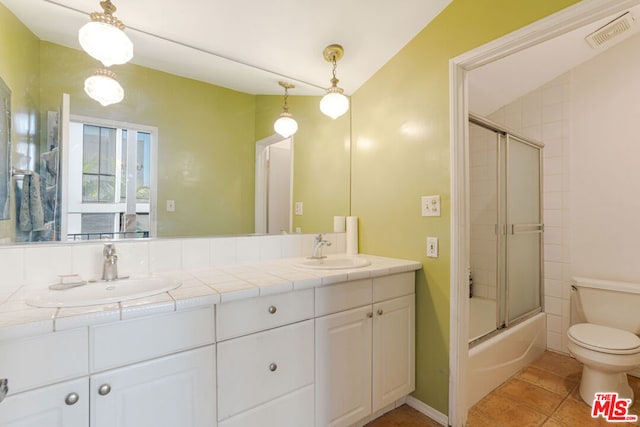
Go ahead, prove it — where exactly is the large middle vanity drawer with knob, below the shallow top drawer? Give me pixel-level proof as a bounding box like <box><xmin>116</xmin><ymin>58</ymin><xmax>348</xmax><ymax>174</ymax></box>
<box><xmin>217</xmin><ymin>320</ymin><xmax>314</xmax><ymax>420</ymax></box>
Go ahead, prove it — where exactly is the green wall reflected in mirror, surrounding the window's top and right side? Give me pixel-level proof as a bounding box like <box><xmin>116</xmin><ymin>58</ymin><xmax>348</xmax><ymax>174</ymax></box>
<box><xmin>40</xmin><ymin>42</ymin><xmax>255</xmax><ymax>236</ymax></box>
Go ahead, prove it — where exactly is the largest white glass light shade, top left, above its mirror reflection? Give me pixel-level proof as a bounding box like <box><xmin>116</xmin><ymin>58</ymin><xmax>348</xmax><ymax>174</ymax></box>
<box><xmin>78</xmin><ymin>21</ymin><xmax>133</xmax><ymax>67</ymax></box>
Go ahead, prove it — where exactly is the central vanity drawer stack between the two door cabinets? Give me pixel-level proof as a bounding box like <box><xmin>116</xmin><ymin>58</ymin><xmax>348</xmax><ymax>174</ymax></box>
<box><xmin>217</xmin><ymin>289</ymin><xmax>314</xmax><ymax>427</ymax></box>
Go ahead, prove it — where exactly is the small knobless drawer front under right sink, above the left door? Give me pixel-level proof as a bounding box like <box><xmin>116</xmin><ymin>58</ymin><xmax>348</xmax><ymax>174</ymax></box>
<box><xmin>316</xmin><ymin>279</ymin><xmax>373</xmax><ymax>317</ymax></box>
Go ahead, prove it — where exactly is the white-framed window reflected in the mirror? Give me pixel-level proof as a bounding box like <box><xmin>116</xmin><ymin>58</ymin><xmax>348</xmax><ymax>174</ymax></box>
<box><xmin>67</xmin><ymin>118</ymin><xmax>157</xmax><ymax>240</ymax></box>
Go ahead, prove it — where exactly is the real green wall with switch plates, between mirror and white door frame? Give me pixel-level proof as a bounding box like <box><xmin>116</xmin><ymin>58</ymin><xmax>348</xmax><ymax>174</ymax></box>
<box><xmin>351</xmin><ymin>0</ymin><xmax>576</xmax><ymax>414</ymax></box>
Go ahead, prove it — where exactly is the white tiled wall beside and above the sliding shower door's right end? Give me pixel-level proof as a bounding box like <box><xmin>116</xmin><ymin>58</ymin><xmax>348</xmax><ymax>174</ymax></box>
<box><xmin>489</xmin><ymin>73</ymin><xmax>571</xmax><ymax>353</ymax></box>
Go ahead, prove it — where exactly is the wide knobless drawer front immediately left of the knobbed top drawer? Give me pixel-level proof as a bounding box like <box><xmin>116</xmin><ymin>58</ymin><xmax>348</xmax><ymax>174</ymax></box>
<box><xmin>89</xmin><ymin>306</ymin><xmax>215</xmax><ymax>372</ymax></box>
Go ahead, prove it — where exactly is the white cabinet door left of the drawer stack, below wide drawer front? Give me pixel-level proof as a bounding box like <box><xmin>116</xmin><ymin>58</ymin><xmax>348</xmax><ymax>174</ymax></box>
<box><xmin>90</xmin><ymin>345</ymin><xmax>216</xmax><ymax>427</ymax></box>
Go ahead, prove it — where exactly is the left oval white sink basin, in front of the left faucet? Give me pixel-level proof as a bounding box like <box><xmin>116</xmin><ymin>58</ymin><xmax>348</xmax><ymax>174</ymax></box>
<box><xmin>26</xmin><ymin>277</ymin><xmax>182</xmax><ymax>307</ymax></box>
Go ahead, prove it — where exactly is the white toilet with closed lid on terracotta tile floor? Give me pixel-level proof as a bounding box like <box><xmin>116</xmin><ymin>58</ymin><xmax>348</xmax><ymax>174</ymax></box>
<box><xmin>567</xmin><ymin>277</ymin><xmax>640</xmax><ymax>406</ymax></box>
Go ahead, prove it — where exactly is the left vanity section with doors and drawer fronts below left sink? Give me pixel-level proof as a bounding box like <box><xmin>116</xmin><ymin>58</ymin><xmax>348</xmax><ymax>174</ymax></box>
<box><xmin>0</xmin><ymin>306</ymin><xmax>216</xmax><ymax>427</ymax></box>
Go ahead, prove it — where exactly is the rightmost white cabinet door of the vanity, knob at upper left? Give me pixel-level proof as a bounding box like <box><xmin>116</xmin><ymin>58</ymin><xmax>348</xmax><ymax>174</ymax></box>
<box><xmin>373</xmin><ymin>294</ymin><xmax>415</xmax><ymax>412</ymax></box>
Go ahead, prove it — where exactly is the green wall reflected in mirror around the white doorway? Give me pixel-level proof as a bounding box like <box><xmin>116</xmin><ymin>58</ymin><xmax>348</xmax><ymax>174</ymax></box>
<box><xmin>256</xmin><ymin>95</ymin><xmax>351</xmax><ymax>233</ymax></box>
